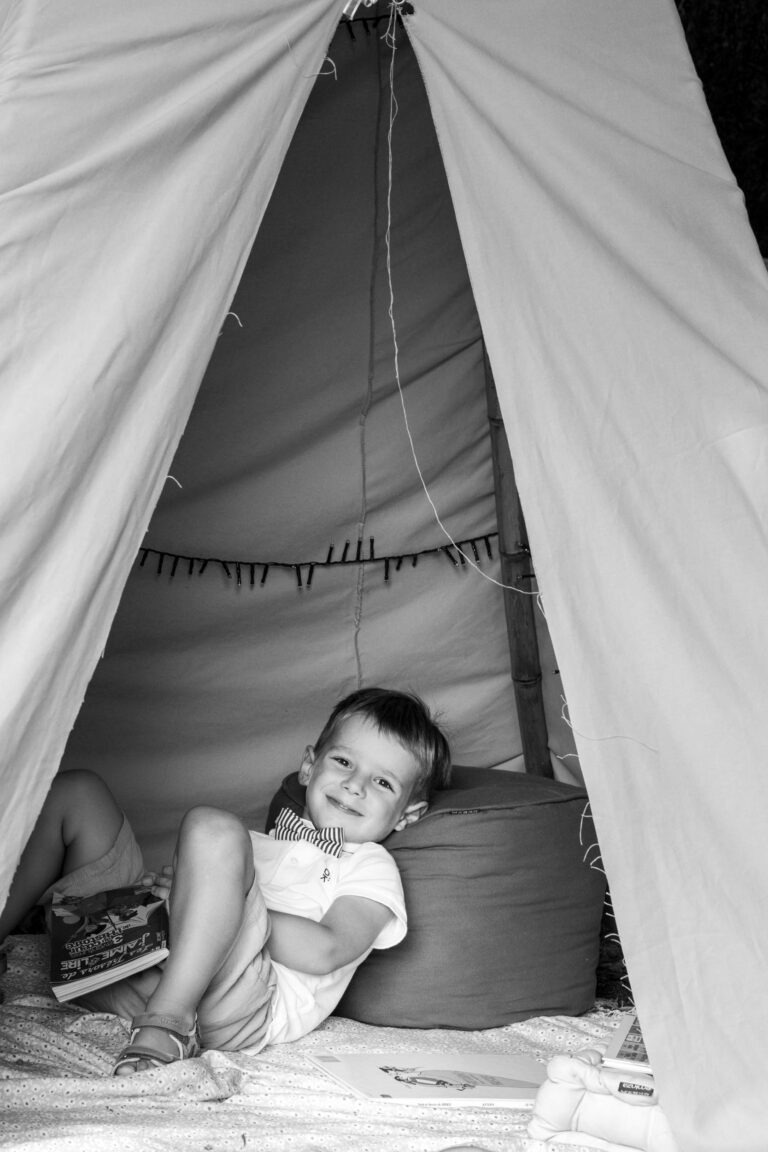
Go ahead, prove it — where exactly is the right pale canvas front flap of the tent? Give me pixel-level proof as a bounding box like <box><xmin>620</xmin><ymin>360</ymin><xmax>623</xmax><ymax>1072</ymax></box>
<box><xmin>408</xmin><ymin>0</ymin><xmax>768</xmax><ymax>1152</ymax></box>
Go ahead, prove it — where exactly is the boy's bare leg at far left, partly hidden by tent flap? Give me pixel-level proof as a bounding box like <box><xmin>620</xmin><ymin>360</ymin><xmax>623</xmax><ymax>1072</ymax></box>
<box><xmin>0</xmin><ymin>770</ymin><xmax>123</xmax><ymax>941</ymax></box>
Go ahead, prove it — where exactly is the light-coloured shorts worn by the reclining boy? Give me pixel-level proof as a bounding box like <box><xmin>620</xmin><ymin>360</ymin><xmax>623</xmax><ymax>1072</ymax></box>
<box><xmin>39</xmin><ymin>817</ymin><xmax>276</xmax><ymax>1052</ymax></box>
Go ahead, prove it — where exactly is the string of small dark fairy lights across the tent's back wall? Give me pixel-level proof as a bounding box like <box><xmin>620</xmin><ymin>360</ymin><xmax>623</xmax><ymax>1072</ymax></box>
<box><xmin>139</xmin><ymin>532</ymin><xmax>499</xmax><ymax>588</ymax></box>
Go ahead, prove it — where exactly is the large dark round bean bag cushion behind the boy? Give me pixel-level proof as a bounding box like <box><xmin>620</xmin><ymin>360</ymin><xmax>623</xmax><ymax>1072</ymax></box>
<box><xmin>267</xmin><ymin>767</ymin><xmax>604</xmax><ymax>1029</ymax></box>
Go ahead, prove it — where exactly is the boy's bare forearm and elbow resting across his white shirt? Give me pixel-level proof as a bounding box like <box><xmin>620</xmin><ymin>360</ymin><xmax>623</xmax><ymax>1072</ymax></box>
<box><xmin>267</xmin><ymin>896</ymin><xmax>393</xmax><ymax>976</ymax></box>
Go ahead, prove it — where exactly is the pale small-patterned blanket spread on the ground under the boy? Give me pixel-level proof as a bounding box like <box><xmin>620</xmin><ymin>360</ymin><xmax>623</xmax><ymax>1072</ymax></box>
<box><xmin>0</xmin><ymin>937</ymin><xmax>615</xmax><ymax>1152</ymax></box>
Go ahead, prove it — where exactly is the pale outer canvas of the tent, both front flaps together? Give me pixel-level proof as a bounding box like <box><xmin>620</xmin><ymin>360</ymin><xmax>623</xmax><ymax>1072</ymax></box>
<box><xmin>0</xmin><ymin>0</ymin><xmax>768</xmax><ymax>1152</ymax></box>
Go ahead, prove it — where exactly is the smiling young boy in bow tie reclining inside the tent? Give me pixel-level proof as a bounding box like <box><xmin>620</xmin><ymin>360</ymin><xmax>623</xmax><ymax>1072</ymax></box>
<box><xmin>0</xmin><ymin>688</ymin><xmax>450</xmax><ymax>1075</ymax></box>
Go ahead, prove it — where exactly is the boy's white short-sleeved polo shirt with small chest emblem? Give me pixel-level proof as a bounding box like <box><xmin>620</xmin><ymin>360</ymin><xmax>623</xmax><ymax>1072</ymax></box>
<box><xmin>251</xmin><ymin>821</ymin><xmax>408</xmax><ymax>1044</ymax></box>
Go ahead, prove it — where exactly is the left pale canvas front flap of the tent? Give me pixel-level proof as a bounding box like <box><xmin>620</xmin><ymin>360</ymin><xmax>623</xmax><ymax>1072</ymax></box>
<box><xmin>0</xmin><ymin>0</ymin><xmax>337</xmax><ymax>899</ymax></box>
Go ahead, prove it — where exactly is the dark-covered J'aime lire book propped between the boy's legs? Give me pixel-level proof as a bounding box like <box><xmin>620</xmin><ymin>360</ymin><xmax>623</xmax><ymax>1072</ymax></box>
<box><xmin>50</xmin><ymin>885</ymin><xmax>168</xmax><ymax>1000</ymax></box>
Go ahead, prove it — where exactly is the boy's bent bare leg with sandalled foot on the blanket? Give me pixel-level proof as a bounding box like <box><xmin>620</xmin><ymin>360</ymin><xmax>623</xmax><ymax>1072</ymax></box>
<box><xmin>116</xmin><ymin>808</ymin><xmax>254</xmax><ymax>1075</ymax></box>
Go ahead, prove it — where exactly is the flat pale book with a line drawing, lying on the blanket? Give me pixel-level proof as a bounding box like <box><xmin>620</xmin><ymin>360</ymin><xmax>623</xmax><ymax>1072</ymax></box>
<box><xmin>309</xmin><ymin>1052</ymin><xmax>547</xmax><ymax>1108</ymax></box>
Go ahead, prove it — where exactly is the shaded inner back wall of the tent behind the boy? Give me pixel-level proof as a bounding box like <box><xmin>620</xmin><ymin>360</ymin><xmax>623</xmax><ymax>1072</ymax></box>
<box><xmin>62</xmin><ymin>10</ymin><xmax>579</xmax><ymax>862</ymax></box>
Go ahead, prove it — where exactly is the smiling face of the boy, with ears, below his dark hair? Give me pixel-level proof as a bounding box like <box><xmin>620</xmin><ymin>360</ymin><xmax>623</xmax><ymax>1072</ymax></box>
<box><xmin>298</xmin><ymin>715</ymin><xmax>427</xmax><ymax>843</ymax></box>
